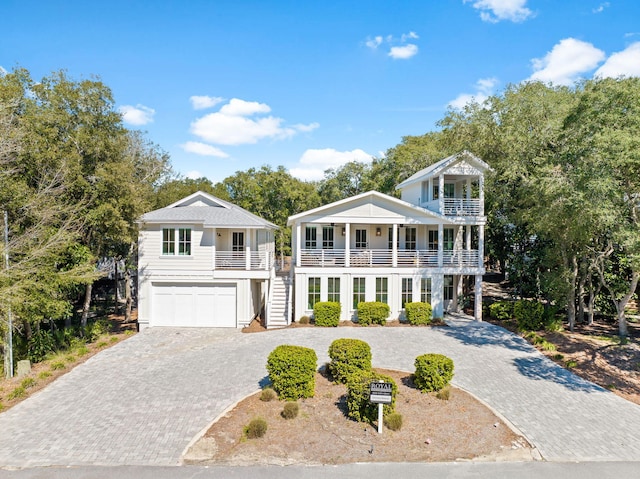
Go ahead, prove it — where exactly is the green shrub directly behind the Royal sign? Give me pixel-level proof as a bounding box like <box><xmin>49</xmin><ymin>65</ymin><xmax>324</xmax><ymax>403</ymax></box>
<box><xmin>347</xmin><ymin>370</ymin><xmax>398</xmax><ymax>424</ymax></box>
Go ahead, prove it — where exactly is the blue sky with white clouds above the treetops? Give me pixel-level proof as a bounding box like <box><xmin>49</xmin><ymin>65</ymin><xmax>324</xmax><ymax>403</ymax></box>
<box><xmin>0</xmin><ymin>0</ymin><xmax>640</xmax><ymax>182</ymax></box>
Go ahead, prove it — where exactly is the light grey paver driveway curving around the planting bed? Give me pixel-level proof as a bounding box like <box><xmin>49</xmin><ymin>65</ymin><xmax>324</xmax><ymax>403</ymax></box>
<box><xmin>0</xmin><ymin>320</ymin><xmax>640</xmax><ymax>468</ymax></box>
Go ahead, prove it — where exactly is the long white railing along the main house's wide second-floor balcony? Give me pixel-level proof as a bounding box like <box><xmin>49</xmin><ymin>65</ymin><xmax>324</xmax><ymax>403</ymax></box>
<box><xmin>300</xmin><ymin>249</ymin><xmax>479</xmax><ymax>268</ymax></box>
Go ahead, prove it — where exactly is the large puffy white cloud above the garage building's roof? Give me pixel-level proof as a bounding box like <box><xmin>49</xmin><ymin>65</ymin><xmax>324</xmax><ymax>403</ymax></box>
<box><xmin>191</xmin><ymin>98</ymin><xmax>320</xmax><ymax>145</ymax></box>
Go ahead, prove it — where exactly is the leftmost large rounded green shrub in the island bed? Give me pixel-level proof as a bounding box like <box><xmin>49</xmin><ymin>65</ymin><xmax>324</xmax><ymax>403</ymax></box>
<box><xmin>267</xmin><ymin>344</ymin><xmax>318</xmax><ymax>399</ymax></box>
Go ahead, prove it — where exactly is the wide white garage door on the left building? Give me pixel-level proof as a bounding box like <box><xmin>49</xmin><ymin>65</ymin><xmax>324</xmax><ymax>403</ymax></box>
<box><xmin>150</xmin><ymin>284</ymin><xmax>236</xmax><ymax>328</ymax></box>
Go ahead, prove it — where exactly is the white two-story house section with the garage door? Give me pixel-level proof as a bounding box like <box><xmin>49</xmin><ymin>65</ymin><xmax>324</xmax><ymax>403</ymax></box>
<box><xmin>138</xmin><ymin>192</ymin><xmax>287</xmax><ymax>329</ymax></box>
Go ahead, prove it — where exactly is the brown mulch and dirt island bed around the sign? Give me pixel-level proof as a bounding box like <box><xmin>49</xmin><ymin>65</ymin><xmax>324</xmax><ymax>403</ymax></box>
<box><xmin>184</xmin><ymin>370</ymin><xmax>532</xmax><ymax>465</ymax></box>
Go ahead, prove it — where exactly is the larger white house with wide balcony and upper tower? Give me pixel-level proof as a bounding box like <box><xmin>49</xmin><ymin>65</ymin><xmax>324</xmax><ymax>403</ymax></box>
<box><xmin>288</xmin><ymin>151</ymin><xmax>490</xmax><ymax>320</ymax></box>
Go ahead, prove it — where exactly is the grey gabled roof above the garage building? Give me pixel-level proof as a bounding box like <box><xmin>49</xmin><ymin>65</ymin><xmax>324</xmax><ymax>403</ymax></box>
<box><xmin>140</xmin><ymin>191</ymin><xmax>278</xmax><ymax>229</ymax></box>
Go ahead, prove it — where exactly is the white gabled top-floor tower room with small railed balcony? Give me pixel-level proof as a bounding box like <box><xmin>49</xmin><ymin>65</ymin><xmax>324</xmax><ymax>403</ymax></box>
<box><xmin>396</xmin><ymin>151</ymin><xmax>491</xmax><ymax>217</ymax></box>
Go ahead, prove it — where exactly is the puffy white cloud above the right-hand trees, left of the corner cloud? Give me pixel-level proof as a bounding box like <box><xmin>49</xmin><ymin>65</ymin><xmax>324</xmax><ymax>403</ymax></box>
<box><xmin>529</xmin><ymin>38</ymin><xmax>605</xmax><ymax>85</ymax></box>
